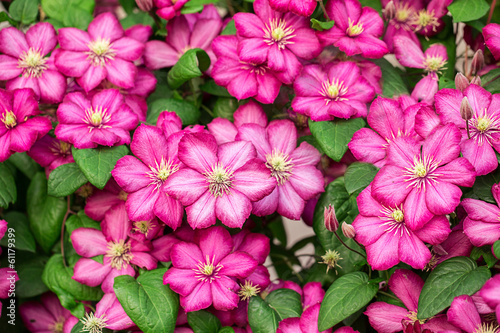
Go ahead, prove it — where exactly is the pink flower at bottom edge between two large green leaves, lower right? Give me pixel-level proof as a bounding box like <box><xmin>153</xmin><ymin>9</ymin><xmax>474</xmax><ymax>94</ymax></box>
<box><xmin>364</xmin><ymin>269</ymin><xmax>460</xmax><ymax>333</ymax></box>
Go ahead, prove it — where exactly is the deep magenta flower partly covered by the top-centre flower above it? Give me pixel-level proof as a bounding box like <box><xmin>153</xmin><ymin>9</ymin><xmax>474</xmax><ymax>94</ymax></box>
<box><xmin>212</xmin><ymin>36</ymin><xmax>281</xmax><ymax>104</ymax></box>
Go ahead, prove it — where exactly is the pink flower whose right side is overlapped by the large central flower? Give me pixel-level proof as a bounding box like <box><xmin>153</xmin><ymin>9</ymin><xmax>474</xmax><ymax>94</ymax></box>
<box><xmin>112</xmin><ymin>124</ymin><xmax>184</xmax><ymax>229</ymax></box>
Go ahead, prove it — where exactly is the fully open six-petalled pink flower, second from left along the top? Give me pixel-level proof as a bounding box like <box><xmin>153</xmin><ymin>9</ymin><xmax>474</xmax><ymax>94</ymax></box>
<box><xmin>55</xmin><ymin>13</ymin><xmax>144</xmax><ymax>92</ymax></box>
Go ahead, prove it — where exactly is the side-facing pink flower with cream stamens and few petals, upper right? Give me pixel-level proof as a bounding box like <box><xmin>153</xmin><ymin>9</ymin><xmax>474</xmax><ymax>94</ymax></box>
<box><xmin>394</xmin><ymin>36</ymin><xmax>448</xmax><ymax>72</ymax></box>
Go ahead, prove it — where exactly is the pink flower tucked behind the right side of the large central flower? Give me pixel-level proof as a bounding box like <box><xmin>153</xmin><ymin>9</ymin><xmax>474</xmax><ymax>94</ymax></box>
<box><xmin>236</xmin><ymin>120</ymin><xmax>324</xmax><ymax>220</ymax></box>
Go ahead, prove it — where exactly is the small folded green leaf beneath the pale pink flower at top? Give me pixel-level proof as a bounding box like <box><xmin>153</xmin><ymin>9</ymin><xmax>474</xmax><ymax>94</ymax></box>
<box><xmin>168</xmin><ymin>49</ymin><xmax>210</xmax><ymax>89</ymax></box>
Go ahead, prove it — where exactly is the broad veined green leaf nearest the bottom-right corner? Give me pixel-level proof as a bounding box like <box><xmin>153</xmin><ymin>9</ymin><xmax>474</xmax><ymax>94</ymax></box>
<box><xmin>417</xmin><ymin>257</ymin><xmax>491</xmax><ymax>319</ymax></box>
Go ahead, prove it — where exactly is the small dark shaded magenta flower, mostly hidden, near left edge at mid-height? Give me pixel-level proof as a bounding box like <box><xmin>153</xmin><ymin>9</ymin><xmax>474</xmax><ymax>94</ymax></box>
<box><xmin>27</xmin><ymin>135</ymin><xmax>75</xmax><ymax>178</ymax></box>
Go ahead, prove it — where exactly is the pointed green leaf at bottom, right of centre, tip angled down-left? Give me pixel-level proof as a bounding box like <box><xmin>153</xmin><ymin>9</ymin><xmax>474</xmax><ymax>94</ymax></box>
<box><xmin>318</xmin><ymin>272</ymin><xmax>378</xmax><ymax>331</ymax></box>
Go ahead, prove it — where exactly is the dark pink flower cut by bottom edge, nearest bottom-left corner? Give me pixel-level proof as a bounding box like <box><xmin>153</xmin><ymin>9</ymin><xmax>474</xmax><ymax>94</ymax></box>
<box><xmin>19</xmin><ymin>293</ymin><xmax>78</xmax><ymax>333</ymax></box>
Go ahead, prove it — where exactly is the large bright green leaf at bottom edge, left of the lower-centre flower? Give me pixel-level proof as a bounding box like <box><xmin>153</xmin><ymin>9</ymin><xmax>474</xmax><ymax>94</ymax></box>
<box><xmin>113</xmin><ymin>268</ymin><xmax>179</xmax><ymax>333</ymax></box>
